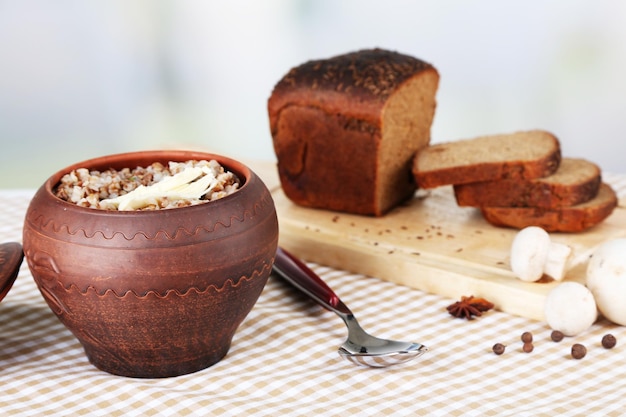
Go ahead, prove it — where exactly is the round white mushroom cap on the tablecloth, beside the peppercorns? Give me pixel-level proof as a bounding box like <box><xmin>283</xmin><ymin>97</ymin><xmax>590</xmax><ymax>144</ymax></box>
<box><xmin>544</xmin><ymin>281</ymin><xmax>598</xmax><ymax>336</ymax></box>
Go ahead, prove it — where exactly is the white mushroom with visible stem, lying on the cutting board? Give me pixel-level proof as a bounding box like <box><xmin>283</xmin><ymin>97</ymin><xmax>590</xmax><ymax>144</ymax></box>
<box><xmin>511</xmin><ymin>226</ymin><xmax>572</xmax><ymax>282</ymax></box>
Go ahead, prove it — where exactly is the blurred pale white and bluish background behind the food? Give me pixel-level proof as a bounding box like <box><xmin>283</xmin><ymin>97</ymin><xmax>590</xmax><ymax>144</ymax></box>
<box><xmin>0</xmin><ymin>0</ymin><xmax>626</xmax><ymax>187</ymax></box>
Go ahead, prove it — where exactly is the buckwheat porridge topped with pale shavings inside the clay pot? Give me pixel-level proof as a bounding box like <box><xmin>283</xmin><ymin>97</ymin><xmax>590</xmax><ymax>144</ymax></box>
<box><xmin>55</xmin><ymin>160</ymin><xmax>240</xmax><ymax>211</ymax></box>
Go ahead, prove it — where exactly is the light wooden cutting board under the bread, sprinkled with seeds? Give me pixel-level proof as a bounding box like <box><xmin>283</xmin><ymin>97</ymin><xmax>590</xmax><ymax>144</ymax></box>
<box><xmin>270</xmin><ymin>180</ymin><xmax>626</xmax><ymax>320</ymax></box>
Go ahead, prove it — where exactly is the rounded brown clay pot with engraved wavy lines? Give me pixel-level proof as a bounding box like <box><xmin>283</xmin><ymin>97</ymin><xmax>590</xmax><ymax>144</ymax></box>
<box><xmin>23</xmin><ymin>151</ymin><xmax>278</xmax><ymax>378</ymax></box>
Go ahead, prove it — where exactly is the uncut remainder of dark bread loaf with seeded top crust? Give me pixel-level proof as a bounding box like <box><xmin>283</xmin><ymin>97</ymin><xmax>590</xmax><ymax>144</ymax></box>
<box><xmin>268</xmin><ymin>49</ymin><xmax>439</xmax><ymax>216</ymax></box>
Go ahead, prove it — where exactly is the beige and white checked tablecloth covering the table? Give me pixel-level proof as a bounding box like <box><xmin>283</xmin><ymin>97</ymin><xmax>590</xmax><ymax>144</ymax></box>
<box><xmin>0</xmin><ymin>163</ymin><xmax>626</xmax><ymax>416</ymax></box>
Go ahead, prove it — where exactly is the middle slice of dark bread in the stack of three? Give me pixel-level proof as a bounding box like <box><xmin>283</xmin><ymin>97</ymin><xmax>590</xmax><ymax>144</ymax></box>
<box><xmin>454</xmin><ymin>158</ymin><xmax>602</xmax><ymax>208</ymax></box>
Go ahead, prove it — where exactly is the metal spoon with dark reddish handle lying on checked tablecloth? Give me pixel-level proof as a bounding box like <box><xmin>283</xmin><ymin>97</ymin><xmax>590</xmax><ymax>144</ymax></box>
<box><xmin>273</xmin><ymin>248</ymin><xmax>428</xmax><ymax>368</ymax></box>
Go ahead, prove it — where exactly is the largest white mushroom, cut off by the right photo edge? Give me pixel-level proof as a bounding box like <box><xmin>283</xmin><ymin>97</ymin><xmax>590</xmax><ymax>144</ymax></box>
<box><xmin>587</xmin><ymin>238</ymin><xmax>626</xmax><ymax>326</ymax></box>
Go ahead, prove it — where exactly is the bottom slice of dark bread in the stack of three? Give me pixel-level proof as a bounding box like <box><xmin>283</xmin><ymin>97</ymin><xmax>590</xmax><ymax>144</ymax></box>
<box><xmin>480</xmin><ymin>183</ymin><xmax>617</xmax><ymax>233</ymax></box>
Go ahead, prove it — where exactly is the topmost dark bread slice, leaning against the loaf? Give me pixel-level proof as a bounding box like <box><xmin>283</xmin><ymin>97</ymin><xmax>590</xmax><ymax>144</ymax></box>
<box><xmin>412</xmin><ymin>130</ymin><xmax>561</xmax><ymax>188</ymax></box>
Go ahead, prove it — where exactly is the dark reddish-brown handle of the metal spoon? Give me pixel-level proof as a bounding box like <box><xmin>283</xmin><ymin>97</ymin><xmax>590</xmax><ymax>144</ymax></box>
<box><xmin>274</xmin><ymin>247</ymin><xmax>352</xmax><ymax>315</ymax></box>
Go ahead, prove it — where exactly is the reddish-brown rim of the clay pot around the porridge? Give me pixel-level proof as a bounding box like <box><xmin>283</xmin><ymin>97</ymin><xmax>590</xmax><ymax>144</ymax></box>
<box><xmin>41</xmin><ymin>149</ymin><xmax>254</xmax><ymax>216</ymax></box>
